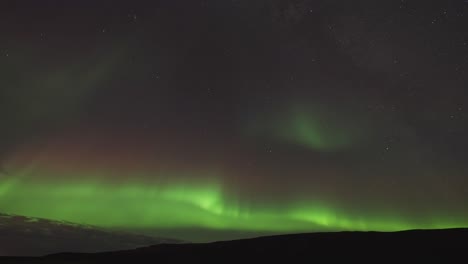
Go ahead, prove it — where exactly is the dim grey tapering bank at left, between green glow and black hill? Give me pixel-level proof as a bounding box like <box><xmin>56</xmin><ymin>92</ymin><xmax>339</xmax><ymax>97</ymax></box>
<box><xmin>0</xmin><ymin>213</ymin><xmax>179</xmax><ymax>256</ymax></box>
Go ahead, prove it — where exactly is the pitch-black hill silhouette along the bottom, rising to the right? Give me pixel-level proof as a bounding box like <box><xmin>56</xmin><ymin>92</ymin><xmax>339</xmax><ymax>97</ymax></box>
<box><xmin>0</xmin><ymin>229</ymin><xmax>468</xmax><ymax>263</ymax></box>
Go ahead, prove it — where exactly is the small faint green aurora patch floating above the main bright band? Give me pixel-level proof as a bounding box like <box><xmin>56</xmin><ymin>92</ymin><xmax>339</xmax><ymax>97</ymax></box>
<box><xmin>246</xmin><ymin>104</ymin><xmax>366</xmax><ymax>152</ymax></box>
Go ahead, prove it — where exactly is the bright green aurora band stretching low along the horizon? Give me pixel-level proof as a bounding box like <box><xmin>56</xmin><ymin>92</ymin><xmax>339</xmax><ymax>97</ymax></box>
<box><xmin>0</xmin><ymin>171</ymin><xmax>468</xmax><ymax>232</ymax></box>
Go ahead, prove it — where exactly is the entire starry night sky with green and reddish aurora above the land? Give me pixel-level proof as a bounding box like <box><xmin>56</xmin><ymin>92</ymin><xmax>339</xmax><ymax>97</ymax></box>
<box><xmin>0</xmin><ymin>0</ymin><xmax>468</xmax><ymax>240</ymax></box>
